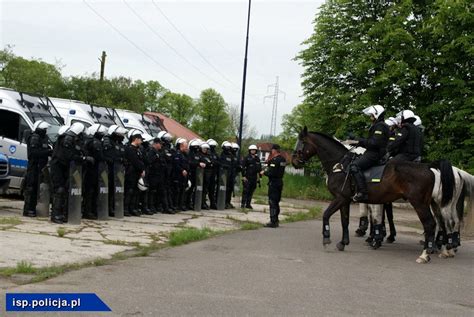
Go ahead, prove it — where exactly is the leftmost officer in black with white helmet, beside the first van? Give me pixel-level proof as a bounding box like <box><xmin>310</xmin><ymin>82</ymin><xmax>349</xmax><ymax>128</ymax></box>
<box><xmin>23</xmin><ymin>120</ymin><xmax>53</xmax><ymax>217</ymax></box>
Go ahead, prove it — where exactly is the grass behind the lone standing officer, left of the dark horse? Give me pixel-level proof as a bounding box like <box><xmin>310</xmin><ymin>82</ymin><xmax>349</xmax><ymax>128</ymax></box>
<box><xmin>255</xmin><ymin>174</ymin><xmax>332</xmax><ymax>200</ymax></box>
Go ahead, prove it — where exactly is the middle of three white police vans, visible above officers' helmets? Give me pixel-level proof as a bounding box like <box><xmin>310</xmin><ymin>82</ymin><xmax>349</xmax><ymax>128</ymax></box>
<box><xmin>50</xmin><ymin>98</ymin><xmax>124</xmax><ymax>127</ymax></box>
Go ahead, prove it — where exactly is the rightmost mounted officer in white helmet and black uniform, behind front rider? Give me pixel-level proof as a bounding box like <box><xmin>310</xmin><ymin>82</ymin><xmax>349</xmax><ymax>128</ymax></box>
<box><xmin>388</xmin><ymin>110</ymin><xmax>422</xmax><ymax>161</ymax></box>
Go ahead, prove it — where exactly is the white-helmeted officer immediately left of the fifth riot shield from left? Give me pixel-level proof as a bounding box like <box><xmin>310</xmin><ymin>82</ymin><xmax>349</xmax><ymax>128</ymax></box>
<box><xmin>173</xmin><ymin>138</ymin><xmax>189</xmax><ymax>211</ymax></box>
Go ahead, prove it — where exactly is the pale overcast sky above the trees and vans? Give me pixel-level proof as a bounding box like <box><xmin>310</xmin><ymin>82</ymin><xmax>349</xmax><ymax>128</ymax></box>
<box><xmin>0</xmin><ymin>0</ymin><xmax>324</xmax><ymax>135</ymax></box>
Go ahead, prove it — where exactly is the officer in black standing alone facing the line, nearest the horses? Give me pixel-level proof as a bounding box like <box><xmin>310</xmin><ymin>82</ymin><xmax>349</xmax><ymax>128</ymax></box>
<box><xmin>260</xmin><ymin>144</ymin><xmax>286</xmax><ymax>228</ymax></box>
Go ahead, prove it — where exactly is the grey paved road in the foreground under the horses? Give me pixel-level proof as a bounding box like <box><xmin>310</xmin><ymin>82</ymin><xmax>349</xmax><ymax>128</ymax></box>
<box><xmin>2</xmin><ymin>221</ymin><xmax>474</xmax><ymax>316</ymax></box>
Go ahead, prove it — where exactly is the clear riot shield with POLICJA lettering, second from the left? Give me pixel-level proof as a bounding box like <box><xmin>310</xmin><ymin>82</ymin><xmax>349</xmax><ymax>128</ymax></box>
<box><xmin>67</xmin><ymin>161</ymin><xmax>82</xmax><ymax>225</ymax></box>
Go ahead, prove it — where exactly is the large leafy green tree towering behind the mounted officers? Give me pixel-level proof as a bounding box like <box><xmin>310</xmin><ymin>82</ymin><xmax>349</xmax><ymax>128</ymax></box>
<box><xmin>292</xmin><ymin>0</ymin><xmax>474</xmax><ymax>171</ymax></box>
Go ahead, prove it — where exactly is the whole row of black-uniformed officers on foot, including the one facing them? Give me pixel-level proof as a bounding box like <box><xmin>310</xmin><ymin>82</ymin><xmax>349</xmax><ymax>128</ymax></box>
<box><xmin>24</xmin><ymin>120</ymin><xmax>286</xmax><ymax>227</ymax></box>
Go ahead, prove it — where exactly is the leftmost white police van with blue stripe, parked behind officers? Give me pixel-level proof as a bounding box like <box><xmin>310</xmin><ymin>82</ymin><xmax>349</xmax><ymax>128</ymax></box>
<box><xmin>0</xmin><ymin>88</ymin><xmax>64</xmax><ymax>191</ymax></box>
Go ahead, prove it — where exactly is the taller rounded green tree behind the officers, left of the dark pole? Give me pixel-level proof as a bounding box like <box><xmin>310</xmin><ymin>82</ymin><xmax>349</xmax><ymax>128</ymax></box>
<box><xmin>192</xmin><ymin>88</ymin><xmax>232</xmax><ymax>142</ymax></box>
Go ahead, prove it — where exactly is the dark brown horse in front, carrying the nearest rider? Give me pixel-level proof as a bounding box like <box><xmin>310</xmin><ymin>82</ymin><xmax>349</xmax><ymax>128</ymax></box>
<box><xmin>292</xmin><ymin>127</ymin><xmax>453</xmax><ymax>263</ymax></box>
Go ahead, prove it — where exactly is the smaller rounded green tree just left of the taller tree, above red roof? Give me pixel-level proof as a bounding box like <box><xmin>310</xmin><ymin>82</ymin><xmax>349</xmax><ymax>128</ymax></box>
<box><xmin>157</xmin><ymin>91</ymin><xmax>196</xmax><ymax>126</ymax></box>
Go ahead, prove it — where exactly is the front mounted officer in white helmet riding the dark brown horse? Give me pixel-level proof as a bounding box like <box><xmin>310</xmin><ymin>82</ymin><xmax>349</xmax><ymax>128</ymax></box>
<box><xmin>349</xmin><ymin>105</ymin><xmax>390</xmax><ymax>202</ymax></box>
